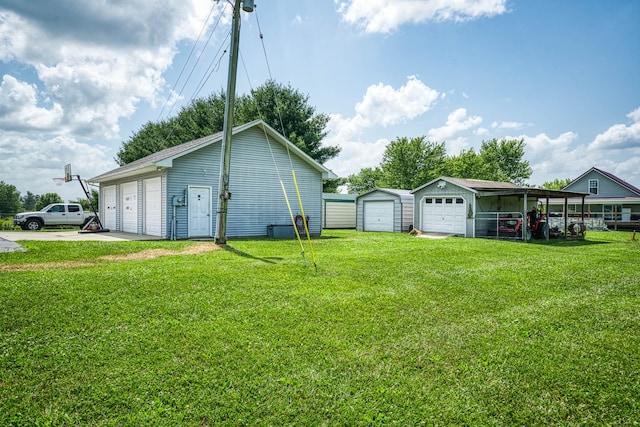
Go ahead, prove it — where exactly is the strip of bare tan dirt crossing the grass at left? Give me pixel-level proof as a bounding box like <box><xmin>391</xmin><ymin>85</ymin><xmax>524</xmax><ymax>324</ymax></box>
<box><xmin>0</xmin><ymin>243</ymin><xmax>220</xmax><ymax>271</ymax></box>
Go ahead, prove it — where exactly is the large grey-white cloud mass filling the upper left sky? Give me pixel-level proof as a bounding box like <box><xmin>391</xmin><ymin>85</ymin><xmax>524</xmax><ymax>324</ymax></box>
<box><xmin>0</xmin><ymin>0</ymin><xmax>222</xmax><ymax>137</ymax></box>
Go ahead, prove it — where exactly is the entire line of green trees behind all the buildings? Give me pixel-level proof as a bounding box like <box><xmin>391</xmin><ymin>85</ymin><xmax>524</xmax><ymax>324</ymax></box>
<box><xmin>0</xmin><ymin>80</ymin><xmax>570</xmax><ymax>221</ymax></box>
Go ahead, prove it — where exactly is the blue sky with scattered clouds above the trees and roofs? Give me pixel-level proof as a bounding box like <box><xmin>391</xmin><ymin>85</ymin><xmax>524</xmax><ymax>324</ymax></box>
<box><xmin>0</xmin><ymin>0</ymin><xmax>640</xmax><ymax>204</ymax></box>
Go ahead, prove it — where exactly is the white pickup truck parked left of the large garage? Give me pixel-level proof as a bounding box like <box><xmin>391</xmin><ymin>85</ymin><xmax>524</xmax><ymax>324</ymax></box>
<box><xmin>13</xmin><ymin>203</ymin><xmax>95</xmax><ymax>230</ymax></box>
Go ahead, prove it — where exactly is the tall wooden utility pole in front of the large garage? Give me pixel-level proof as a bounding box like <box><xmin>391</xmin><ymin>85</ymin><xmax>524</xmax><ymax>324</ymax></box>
<box><xmin>215</xmin><ymin>0</ymin><xmax>253</xmax><ymax>245</ymax></box>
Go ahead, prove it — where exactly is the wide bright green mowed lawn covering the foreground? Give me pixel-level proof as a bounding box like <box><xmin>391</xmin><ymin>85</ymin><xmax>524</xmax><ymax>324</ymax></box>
<box><xmin>0</xmin><ymin>231</ymin><xmax>640</xmax><ymax>426</ymax></box>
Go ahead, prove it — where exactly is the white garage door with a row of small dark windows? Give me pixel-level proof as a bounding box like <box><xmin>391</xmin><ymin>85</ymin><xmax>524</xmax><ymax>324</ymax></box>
<box><xmin>422</xmin><ymin>197</ymin><xmax>467</xmax><ymax>235</ymax></box>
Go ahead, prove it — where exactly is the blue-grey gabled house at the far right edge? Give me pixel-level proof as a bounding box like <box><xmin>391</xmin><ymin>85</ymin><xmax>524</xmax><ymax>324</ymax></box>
<box><xmin>550</xmin><ymin>167</ymin><xmax>640</xmax><ymax>229</ymax></box>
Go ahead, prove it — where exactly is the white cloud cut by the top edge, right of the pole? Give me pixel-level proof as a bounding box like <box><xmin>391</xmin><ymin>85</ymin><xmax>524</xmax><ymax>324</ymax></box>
<box><xmin>335</xmin><ymin>0</ymin><xmax>507</xmax><ymax>33</ymax></box>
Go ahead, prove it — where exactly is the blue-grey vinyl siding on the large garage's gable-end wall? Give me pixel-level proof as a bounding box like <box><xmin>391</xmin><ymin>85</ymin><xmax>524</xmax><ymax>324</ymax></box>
<box><xmin>167</xmin><ymin>128</ymin><xmax>322</xmax><ymax>239</ymax></box>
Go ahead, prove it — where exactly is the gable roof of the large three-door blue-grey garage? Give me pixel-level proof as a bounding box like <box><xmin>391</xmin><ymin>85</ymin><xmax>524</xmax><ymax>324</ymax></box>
<box><xmin>89</xmin><ymin>120</ymin><xmax>337</xmax><ymax>183</ymax></box>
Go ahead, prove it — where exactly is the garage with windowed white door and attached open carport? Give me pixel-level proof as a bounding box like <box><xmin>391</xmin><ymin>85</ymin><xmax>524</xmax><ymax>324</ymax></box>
<box><xmin>412</xmin><ymin>176</ymin><xmax>586</xmax><ymax>239</ymax></box>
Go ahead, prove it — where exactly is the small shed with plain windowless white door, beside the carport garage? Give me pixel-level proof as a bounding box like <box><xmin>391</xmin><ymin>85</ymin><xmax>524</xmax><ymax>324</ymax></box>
<box><xmin>356</xmin><ymin>188</ymin><xmax>413</xmax><ymax>233</ymax></box>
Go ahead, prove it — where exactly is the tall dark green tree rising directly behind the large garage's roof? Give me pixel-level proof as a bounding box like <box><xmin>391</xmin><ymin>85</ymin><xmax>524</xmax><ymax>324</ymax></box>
<box><xmin>116</xmin><ymin>80</ymin><xmax>340</xmax><ymax>165</ymax></box>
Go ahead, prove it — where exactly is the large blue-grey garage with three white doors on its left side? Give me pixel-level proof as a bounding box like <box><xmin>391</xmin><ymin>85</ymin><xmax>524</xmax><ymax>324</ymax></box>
<box><xmin>89</xmin><ymin>120</ymin><xmax>336</xmax><ymax>239</ymax></box>
